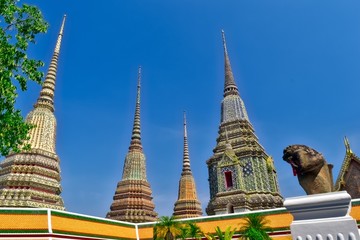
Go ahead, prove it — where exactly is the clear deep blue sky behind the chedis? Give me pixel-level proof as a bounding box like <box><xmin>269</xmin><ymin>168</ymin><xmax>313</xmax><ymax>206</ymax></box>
<box><xmin>11</xmin><ymin>0</ymin><xmax>360</xmax><ymax>217</ymax></box>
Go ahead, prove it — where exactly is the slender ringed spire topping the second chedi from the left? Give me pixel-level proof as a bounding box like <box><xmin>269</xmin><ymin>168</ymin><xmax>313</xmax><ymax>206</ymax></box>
<box><xmin>129</xmin><ymin>66</ymin><xmax>142</xmax><ymax>150</ymax></box>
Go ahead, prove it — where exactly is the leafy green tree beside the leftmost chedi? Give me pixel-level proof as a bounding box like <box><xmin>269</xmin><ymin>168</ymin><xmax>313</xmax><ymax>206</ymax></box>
<box><xmin>0</xmin><ymin>0</ymin><xmax>48</xmax><ymax>155</ymax></box>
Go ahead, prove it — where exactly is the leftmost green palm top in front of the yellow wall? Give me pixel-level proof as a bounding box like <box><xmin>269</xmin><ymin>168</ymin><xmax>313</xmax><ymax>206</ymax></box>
<box><xmin>154</xmin><ymin>216</ymin><xmax>182</xmax><ymax>240</ymax></box>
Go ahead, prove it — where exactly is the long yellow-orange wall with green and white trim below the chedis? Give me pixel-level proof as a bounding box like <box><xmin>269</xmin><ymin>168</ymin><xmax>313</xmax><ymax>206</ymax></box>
<box><xmin>0</xmin><ymin>200</ymin><xmax>360</xmax><ymax>240</ymax></box>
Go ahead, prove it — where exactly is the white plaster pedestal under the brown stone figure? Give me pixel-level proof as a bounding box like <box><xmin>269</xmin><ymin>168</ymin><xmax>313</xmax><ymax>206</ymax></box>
<box><xmin>284</xmin><ymin>191</ymin><xmax>360</xmax><ymax>240</ymax></box>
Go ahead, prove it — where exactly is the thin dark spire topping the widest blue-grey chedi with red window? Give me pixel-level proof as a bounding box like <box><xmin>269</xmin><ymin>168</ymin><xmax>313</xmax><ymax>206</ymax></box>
<box><xmin>221</xmin><ymin>30</ymin><xmax>239</xmax><ymax>96</ymax></box>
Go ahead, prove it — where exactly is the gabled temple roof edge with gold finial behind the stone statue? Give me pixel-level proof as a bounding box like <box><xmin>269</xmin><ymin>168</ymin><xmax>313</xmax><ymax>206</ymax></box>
<box><xmin>334</xmin><ymin>137</ymin><xmax>360</xmax><ymax>199</ymax></box>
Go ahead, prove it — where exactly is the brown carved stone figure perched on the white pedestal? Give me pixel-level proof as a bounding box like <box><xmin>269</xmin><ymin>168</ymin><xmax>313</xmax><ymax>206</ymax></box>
<box><xmin>283</xmin><ymin>145</ymin><xmax>333</xmax><ymax>195</ymax></box>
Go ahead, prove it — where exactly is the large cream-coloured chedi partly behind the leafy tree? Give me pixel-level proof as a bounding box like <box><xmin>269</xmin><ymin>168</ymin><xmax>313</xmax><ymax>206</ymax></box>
<box><xmin>0</xmin><ymin>16</ymin><xmax>66</xmax><ymax>210</ymax></box>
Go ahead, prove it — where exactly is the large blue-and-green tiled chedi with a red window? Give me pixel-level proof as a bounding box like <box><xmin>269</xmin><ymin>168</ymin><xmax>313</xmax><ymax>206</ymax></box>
<box><xmin>206</xmin><ymin>31</ymin><xmax>283</xmax><ymax>215</ymax></box>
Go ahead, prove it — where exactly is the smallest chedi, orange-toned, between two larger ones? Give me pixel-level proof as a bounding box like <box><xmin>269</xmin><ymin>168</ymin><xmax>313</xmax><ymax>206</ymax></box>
<box><xmin>173</xmin><ymin>113</ymin><xmax>202</xmax><ymax>218</ymax></box>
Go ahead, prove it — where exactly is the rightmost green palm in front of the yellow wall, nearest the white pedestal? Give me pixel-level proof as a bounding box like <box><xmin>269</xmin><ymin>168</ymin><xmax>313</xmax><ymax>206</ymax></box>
<box><xmin>240</xmin><ymin>214</ymin><xmax>272</xmax><ymax>240</ymax></box>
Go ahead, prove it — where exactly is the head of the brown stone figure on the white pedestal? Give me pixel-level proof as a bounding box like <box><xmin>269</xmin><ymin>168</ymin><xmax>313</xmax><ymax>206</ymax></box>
<box><xmin>283</xmin><ymin>145</ymin><xmax>325</xmax><ymax>176</ymax></box>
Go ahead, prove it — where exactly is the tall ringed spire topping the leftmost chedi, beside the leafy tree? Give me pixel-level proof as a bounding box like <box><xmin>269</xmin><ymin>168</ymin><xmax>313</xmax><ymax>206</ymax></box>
<box><xmin>34</xmin><ymin>15</ymin><xmax>66</xmax><ymax>112</ymax></box>
